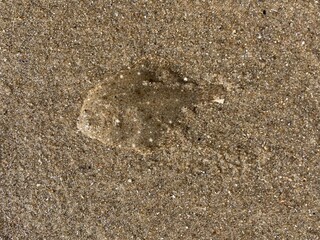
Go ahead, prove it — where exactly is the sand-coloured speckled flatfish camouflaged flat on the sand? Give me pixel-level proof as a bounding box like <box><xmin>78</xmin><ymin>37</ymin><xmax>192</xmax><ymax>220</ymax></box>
<box><xmin>77</xmin><ymin>57</ymin><xmax>226</xmax><ymax>154</ymax></box>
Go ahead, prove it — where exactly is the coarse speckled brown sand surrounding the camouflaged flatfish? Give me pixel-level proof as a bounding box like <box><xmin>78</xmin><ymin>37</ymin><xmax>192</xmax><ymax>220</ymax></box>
<box><xmin>0</xmin><ymin>0</ymin><xmax>320</xmax><ymax>239</ymax></box>
